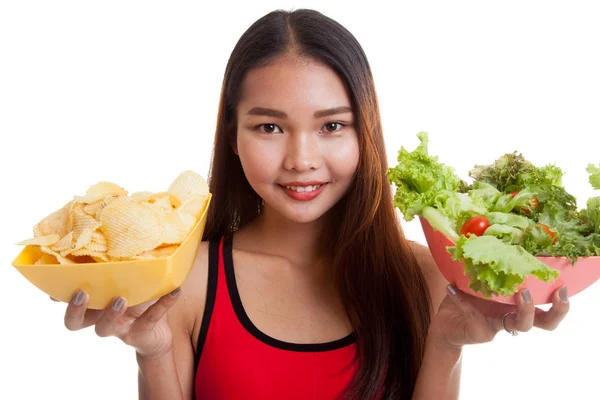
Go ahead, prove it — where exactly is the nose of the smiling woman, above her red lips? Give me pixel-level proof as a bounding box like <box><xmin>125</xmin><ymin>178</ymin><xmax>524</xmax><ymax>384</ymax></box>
<box><xmin>283</xmin><ymin>132</ymin><xmax>322</xmax><ymax>172</ymax></box>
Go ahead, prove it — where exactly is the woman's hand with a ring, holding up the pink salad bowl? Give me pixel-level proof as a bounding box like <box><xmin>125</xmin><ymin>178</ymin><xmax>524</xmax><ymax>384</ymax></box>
<box><xmin>429</xmin><ymin>285</ymin><xmax>569</xmax><ymax>349</ymax></box>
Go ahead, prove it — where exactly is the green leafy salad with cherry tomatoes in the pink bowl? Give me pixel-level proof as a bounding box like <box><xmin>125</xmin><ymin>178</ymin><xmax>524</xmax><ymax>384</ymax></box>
<box><xmin>388</xmin><ymin>132</ymin><xmax>600</xmax><ymax>297</ymax></box>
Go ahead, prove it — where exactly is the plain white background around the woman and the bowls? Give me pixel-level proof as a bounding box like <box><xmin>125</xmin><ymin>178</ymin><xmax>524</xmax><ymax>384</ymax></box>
<box><xmin>0</xmin><ymin>1</ymin><xmax>600</xmax><ymax>400</ymax></box>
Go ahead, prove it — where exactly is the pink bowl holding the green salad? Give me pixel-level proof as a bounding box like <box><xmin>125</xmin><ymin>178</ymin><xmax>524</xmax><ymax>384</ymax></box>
<box><xmin>420</xmin><ymin>217</ymin><xmax>600</xmax><ymax>305</ymax></box>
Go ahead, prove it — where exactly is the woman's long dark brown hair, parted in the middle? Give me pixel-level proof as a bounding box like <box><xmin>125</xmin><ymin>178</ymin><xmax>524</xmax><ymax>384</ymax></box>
<box><xmin>204</xmin><ymin>9</ymin><xmax>430</xmax><ymax>399</ymax></box>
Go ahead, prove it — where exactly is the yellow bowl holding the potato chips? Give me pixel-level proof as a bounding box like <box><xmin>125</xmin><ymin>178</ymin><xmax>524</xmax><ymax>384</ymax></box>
<box><xmin>12</xmin><ymin>193</ymin><xmax>212</xmax><ymax>309</ymax></box>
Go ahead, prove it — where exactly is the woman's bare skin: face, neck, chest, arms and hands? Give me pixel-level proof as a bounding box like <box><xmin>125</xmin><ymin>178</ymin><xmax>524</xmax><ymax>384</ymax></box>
<box><xmin>57</xmin><ymin>55</ymin><xmax>569</xmax><ymax>399</ymax></box>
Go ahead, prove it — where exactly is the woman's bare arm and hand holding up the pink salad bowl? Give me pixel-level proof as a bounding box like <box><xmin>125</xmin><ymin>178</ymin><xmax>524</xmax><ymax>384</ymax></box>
<box><xmin>413</xmin><ymin>239</ymin><xmax>569</xmax><ymax>400</ymax></box>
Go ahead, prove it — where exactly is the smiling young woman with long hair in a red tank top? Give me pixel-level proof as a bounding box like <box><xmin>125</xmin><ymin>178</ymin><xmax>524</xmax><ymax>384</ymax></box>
<box><xmin>58</xmin><ymin>10</ymin><xmax>569</xmax><ymax>400</ymax></box>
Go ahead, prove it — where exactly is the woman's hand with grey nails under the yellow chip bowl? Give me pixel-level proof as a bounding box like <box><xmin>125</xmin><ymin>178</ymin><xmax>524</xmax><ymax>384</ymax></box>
<box><xmin>53</xmin><ymin>288</ymin><xmax>181</xmax><ymax>359</ymax></box>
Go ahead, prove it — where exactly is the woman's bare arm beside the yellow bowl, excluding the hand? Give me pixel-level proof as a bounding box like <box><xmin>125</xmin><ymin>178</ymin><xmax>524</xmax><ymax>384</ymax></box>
<box><xmin>136</xmin><ymin>242</ymin><xmax>208</xmax><ymax>400</ymax></box>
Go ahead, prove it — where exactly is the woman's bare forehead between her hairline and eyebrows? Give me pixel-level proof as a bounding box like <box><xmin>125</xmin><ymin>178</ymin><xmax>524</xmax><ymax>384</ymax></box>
<box><xmin>238</xmin><ymin>57</ymin><xmax>351</xmax><ymax>115</ymax></box>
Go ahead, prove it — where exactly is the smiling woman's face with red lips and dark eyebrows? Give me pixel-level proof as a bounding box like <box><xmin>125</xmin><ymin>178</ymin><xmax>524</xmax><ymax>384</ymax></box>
<box><xmin>235</xmin><ymin>57</ymin><xmax>359</xmax><ymax>223</ymax></box>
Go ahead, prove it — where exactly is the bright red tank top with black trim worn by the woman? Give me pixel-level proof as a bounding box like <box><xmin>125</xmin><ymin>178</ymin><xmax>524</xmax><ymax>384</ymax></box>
<box><xmin>195</xmin><ymin>235</ymin><xmax>357</xmax><ymax>400</ymax></box>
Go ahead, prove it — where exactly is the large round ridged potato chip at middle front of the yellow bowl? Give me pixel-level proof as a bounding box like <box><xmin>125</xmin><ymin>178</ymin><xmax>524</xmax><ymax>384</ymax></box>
<box><xmin>99</xmin><ymin>197</ymin><xmax>164</xmax><ymax>258</ymax></box>
